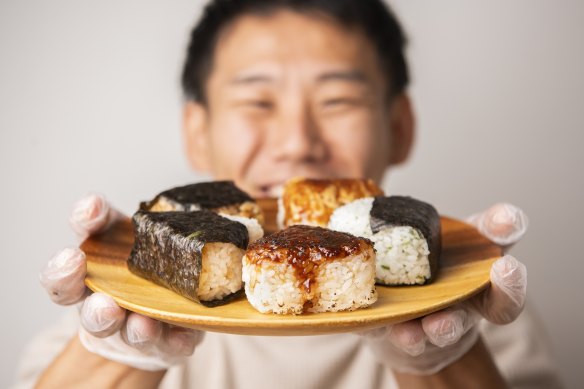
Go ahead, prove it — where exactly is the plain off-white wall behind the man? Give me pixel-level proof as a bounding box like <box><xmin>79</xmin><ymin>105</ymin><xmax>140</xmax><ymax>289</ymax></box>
<box><xmin>0</xmin><ymin>0</ymin><xmax>584</xmax><ymax>388</ymax></box>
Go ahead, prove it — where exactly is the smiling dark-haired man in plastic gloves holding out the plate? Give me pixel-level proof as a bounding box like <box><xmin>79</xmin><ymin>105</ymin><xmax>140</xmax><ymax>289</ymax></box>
<box><xmin>19</xmin><ymin>0</ymin><xmax>555</xmax><ymax>388</ymax></box>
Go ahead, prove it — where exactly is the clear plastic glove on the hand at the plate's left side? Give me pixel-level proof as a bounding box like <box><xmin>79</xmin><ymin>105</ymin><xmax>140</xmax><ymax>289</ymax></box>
<box><xmin>40</xmin><ymin>194</ymin><xmax>204</xmax><ymax>370</ymax></box>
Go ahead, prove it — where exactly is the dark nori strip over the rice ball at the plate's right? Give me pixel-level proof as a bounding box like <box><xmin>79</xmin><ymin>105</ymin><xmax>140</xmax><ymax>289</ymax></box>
<box><xmin>370</xmin><ymin>196</ymin><xmax>442</xmax><ymax>282</ymax></box>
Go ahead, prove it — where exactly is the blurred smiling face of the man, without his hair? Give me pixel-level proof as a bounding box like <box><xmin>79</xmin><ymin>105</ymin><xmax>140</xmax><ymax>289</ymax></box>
<box><xmin>185</xmin><ymin>11</ymin><xmax>408</xmax><ymax>197</ymax></box>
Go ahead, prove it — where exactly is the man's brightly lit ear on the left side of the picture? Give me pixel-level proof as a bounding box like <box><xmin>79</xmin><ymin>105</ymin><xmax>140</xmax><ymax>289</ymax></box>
<box><xmin>183</xmin><ymin>101</ymin><xmax>211</xmax><ymax>173</ymax></box>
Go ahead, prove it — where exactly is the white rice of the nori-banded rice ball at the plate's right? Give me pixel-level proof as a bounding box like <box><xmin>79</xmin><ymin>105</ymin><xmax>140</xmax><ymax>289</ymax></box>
<box><xmin>329</xmin><ymin>197</ymin><xmax>431</xmax><ymax>285</ymax></box>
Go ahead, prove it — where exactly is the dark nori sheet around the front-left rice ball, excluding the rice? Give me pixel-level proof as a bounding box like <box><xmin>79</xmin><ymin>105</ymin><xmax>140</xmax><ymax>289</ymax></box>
<box><xmin>128</xmin><ymin>211</ymin><xmax>249</xmax><ymax>306</ymax></box>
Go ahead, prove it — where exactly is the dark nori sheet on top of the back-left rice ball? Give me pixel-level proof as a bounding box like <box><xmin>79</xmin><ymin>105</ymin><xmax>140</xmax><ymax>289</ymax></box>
<box><xmin>140</xmin><ymin>181</ymin><xmax>254</xmax><ymax>210</ymax></box>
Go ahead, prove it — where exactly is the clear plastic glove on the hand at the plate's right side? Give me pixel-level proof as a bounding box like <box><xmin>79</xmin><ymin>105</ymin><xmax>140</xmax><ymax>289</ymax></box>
<box><xmin>360</xmin><ymin>203</ymin><xmax>528</xmax><ymax>375</ymax></box>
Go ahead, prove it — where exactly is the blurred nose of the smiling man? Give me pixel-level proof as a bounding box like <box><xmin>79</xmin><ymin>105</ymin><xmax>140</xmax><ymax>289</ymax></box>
<box><xmin>271</xmin><ymin>103</ymin><xmax>328</xmax><ymax>163</ymax></box>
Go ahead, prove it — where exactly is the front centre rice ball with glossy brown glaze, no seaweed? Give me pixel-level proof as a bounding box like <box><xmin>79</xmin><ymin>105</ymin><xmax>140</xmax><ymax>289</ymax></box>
<box><xmin>243</xmin><ymin>225</ymin><xmax>377</xmax><ymax>314</ymax></box>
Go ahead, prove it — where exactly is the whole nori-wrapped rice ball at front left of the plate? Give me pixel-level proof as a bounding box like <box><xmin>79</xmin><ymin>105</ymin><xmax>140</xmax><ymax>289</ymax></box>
<box><xmin>128</xmin><ymin>210</ymin><xmax>249</xmax><ymax>306</ymax></box>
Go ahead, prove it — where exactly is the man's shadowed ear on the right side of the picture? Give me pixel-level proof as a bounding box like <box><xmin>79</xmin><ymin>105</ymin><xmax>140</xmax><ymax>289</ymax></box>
<box><xmin>389</xmin><ymin>93</ymin><xmax>415</xmax><ymax>165</ymax></box>
